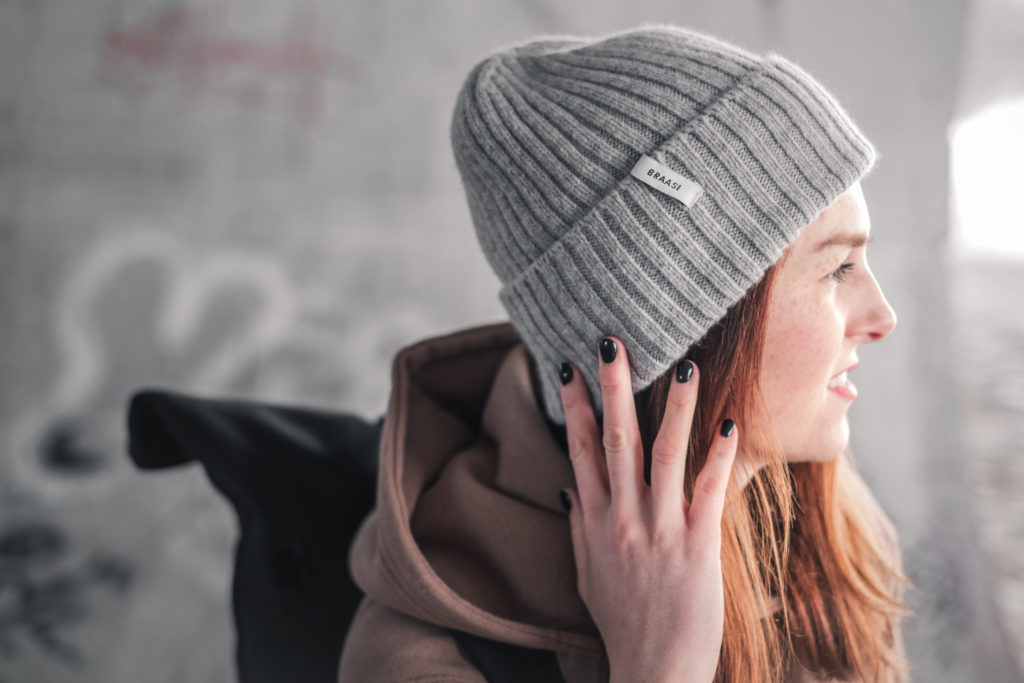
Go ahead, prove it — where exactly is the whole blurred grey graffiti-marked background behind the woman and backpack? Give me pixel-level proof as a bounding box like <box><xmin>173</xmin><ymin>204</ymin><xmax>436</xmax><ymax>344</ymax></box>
<box><xmin>0</xmin><ymin>0</ymin><xmax>1024</xmax><ymax>683</ymax></box>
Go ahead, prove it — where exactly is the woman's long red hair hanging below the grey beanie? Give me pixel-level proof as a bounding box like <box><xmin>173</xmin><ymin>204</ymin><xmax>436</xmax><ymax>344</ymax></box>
<box><xmin>635</xmin><ymin>263</ymin><xmax>910</xmax><ymax>683</ymax></box>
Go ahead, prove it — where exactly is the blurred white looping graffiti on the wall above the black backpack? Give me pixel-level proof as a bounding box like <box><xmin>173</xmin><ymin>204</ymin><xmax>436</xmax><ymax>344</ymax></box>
<box><xmin>4</xmin><ymin>229</ymin><xmax>296</xmax><ymax>502</ymax></box>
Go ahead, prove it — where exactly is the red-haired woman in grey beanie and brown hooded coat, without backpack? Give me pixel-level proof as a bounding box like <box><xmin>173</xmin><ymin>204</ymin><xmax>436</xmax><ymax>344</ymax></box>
<box><xmin>340</xmin><ymin>25</ymin><xmax>906</xmax><ymax>683</ymax></box>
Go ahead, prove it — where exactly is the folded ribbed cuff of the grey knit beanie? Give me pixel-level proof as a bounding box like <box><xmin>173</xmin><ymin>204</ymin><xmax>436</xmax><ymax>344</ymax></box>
<box><xmin>499</xmin><ymin>53</ymin><xmax>877</xmax><ymax>424</ymax></box>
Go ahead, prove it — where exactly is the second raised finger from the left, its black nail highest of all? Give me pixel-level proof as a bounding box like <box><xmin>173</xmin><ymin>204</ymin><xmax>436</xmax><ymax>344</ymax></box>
<box><xmin>598</xmin><ymin>337</ymin><xmax>646</xmax><ymax>511</ymax></box>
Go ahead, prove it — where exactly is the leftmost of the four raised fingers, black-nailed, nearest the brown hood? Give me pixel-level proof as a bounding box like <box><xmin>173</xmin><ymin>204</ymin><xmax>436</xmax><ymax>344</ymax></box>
<box><xmin>561</xmin><ymin>362</ymin><xmax>608</xmax><ymax>515</ymax></box>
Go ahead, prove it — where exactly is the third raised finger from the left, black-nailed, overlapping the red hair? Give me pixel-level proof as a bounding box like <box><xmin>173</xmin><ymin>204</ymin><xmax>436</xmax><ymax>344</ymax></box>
<box><xmin>650</xmin><ymin>360</ymin><xmax>699</xmax><ymax>528</ymax></box>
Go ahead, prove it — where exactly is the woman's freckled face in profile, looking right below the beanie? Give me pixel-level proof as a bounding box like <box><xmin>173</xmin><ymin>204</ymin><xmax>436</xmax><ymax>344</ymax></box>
<box><xmin>761</xmin><ymin>182</ymin><xmax>896</xmax><ymax>462</ymax></box>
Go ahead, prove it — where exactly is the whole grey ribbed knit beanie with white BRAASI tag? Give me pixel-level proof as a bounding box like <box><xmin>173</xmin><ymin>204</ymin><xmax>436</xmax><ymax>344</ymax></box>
<box><xmin>451</xmin><ymin>24</ymin><xmax>876</xmax><ymax>424</ymax></box>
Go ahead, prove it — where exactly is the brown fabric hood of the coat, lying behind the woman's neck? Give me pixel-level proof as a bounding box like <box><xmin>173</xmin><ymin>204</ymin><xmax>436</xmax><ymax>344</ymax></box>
<box><xmin>349</xmin><ymin>323</ymin><xmax>603</xmax><ymax>654</ymax></box>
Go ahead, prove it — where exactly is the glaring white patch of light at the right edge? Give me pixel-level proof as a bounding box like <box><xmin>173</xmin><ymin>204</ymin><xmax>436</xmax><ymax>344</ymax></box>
<box><xmin>950</xmin><ymin>99</ymin><xmax>1024</xmax><ymax>260</ymax></box>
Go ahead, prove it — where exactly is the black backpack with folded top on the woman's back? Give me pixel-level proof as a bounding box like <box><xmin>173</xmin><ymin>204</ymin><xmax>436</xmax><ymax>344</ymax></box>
<box><xmin>127</xmin><ymin>388</ymin><xmax>564</xmax><ymax>683</ymax></box>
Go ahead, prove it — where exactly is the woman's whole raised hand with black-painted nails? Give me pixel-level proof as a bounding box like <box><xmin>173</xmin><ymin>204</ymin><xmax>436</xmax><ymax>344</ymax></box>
<box><xmin>561</xmin><ymin>337</ymin><xmax>738</xmax><ymax>683</ymax></box>
